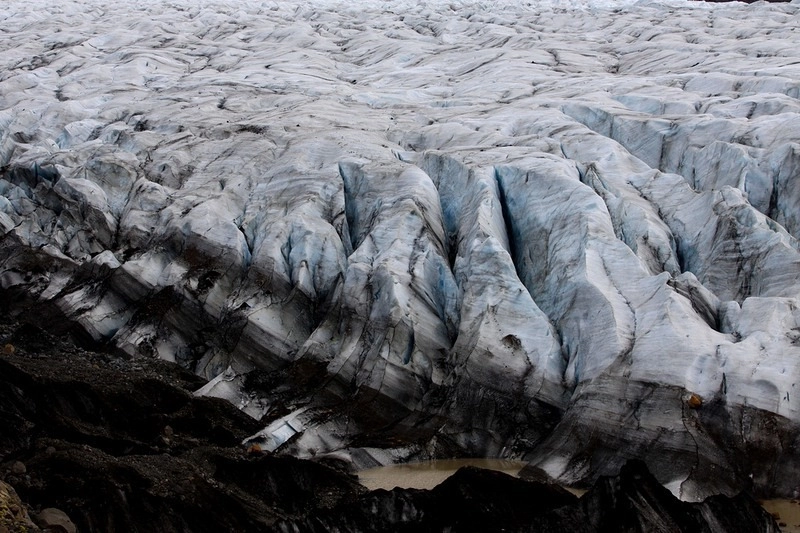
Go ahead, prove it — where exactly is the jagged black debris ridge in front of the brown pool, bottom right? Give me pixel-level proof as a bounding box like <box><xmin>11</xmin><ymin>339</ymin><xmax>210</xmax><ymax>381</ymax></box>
<box><xmin>276</xmin><ymin>461</ymin><xmax>780</xmax><ymax>533</ymax></box>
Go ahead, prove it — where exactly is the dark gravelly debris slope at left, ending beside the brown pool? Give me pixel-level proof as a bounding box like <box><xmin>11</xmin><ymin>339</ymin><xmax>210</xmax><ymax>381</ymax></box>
<box><xmin>0</xmin><ymin>322</ymin><xmax>365</xmax><ymax>532</ymax></box>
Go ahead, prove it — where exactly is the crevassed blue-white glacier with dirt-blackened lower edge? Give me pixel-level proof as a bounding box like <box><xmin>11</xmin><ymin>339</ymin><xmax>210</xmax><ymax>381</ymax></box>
<box><xmin>0</xmin><ymin>0</ymin><xmax>800</xmax><ymax>500</ymax></box>
